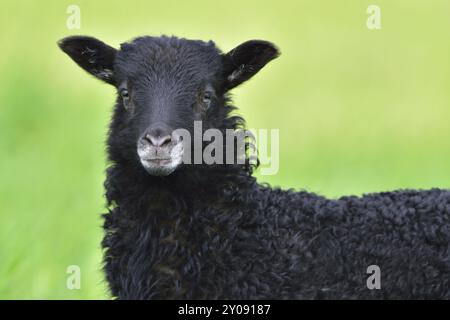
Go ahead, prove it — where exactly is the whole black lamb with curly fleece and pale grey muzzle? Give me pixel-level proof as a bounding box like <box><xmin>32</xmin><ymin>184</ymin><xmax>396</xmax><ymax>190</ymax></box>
<box><xmin>59</xmin><ymin>36</ymin><xmax>450</xmax><ymax>299</ymax></box>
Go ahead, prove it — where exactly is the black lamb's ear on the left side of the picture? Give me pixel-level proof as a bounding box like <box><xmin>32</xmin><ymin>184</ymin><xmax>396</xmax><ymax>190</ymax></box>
<box><xmin>58</xmin><ymin>36</ymin><xmax>117</xmax><ymax>85</ymax></box>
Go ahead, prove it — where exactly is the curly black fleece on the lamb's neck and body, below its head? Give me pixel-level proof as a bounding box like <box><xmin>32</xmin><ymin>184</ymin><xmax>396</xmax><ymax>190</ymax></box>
<box><xmin>103</xmin><ymin>115</ymin><xmax>450</xmax><ymax>299</ymax></box>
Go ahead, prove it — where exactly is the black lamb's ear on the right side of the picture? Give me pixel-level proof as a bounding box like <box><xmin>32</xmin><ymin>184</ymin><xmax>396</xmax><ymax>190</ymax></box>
<box><xmin>224</xmin><ymin>40</ymin><xmax>280</xmax><ymax>90</ymax></box>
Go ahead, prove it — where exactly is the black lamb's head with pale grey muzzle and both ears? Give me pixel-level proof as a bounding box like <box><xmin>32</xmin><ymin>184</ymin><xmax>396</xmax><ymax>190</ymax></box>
<box><xmin>59</xmin><ymin>36</ymin><xmax>279</xmax><ymax>176</ymax></box>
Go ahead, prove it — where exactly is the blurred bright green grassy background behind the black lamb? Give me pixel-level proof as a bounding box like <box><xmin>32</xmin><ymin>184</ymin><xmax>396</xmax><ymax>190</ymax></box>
<box><xmin>0</xmin><ymin>0</ymin><xmax>450</xmax><ymax>299</ymax></box>
